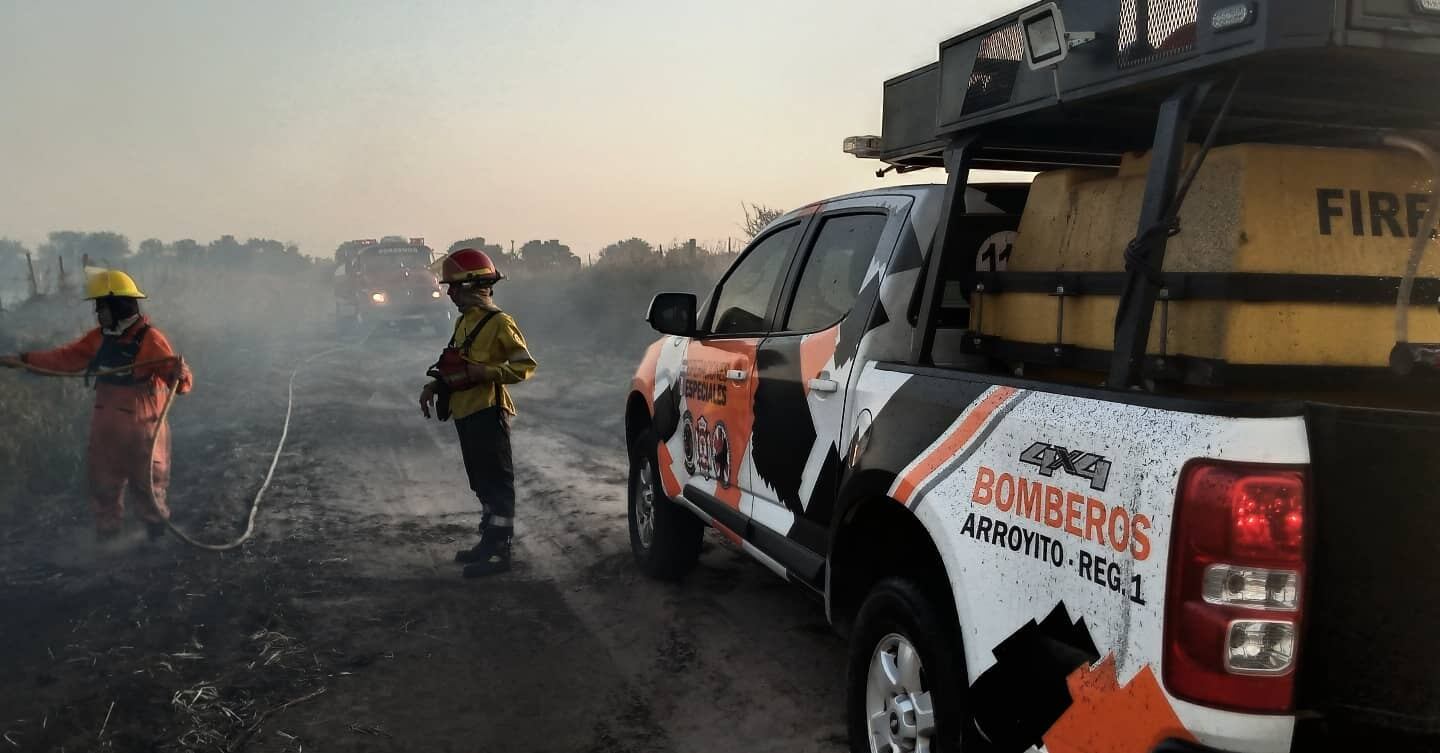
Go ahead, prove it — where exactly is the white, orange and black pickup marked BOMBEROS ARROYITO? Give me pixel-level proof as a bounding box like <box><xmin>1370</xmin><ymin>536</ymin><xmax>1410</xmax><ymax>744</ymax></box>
<box><xmin>625</xmin><ymin>0</ymin><xmax>1440</xmax><ymax>753</ymax></box>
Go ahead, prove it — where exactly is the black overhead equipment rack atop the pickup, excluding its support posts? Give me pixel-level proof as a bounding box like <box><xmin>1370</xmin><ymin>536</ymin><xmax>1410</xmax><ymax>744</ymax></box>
<box><xmin>867</xmin><ymin>0</ymin><xmax>1440</xmax><ymax>170</ymax></box>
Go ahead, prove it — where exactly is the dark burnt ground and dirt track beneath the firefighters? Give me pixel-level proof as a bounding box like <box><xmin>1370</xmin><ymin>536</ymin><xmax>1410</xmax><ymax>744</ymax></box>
<box><xmin>0</xmin><ymin>328</ymin><xmax>844</xmax><ymax>753</ymax></box>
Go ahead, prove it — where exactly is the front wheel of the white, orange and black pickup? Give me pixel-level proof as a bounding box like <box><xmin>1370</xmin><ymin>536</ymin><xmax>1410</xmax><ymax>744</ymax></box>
<box><xmin>628</xmin><ymin>429</ymin><xmax>706</xmax><ymax>580</ymax></box>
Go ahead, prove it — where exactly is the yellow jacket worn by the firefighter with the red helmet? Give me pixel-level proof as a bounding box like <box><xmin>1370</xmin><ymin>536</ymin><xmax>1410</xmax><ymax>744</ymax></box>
<box><xmin>451</xmin><ymin>307</ymin><xmax>537</xmax><ymax>420</ymax></box>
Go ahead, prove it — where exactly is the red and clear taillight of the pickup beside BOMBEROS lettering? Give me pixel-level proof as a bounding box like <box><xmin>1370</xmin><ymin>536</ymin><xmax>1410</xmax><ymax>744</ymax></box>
<box><xmin>1164</xmin><ymin>461</ymin><xmax>1306</xmax><ymax>713</ymax></box>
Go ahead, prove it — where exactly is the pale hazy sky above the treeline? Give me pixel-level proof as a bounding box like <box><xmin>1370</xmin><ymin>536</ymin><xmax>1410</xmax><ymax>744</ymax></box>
<box><xmin>0</xmin><ymin>0</ymin><xmax>1027</xmax><ymax>255</ymax></box>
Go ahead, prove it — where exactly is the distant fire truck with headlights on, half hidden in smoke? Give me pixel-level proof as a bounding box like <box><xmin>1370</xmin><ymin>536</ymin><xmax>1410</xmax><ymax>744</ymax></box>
<box><xmin>334</xmin><ymin>238</ymin><xmax>452</xmax><ymax>334</ymax></box>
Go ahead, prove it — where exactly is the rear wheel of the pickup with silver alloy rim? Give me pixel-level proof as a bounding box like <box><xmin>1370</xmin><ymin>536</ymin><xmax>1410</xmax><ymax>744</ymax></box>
<box><xmin>845</xmin><ymin>577</ymin><xmax>966</xmax><ymax>753</ymax></box>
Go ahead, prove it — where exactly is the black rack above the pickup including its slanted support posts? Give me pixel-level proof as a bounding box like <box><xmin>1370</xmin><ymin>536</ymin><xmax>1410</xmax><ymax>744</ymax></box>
<box><xmin>881</xmin><ymin>0</ymin><xmax>1440</xmax><ymax>390</ymax></box>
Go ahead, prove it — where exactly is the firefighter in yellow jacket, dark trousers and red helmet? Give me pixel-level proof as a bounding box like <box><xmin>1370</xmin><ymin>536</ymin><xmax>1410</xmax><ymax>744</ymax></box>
<box><xmin>420</xmin><ymin>249</ymin><xmax>536</xmax><ymax>577</ymax></box>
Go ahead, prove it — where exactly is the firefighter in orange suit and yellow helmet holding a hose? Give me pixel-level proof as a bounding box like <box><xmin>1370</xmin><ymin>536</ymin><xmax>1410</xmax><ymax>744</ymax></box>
<box><xmin>0</xmin><ymin>269</ymin><xmax>192</xmax><ymax>540</ymax></box>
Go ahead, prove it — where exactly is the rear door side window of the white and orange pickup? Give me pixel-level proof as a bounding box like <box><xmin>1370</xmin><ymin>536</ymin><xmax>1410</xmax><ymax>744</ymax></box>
<box><xmin>785</xmin><ymin>215</ymin><xmax>888</xmax><ymax>333</ymax></box>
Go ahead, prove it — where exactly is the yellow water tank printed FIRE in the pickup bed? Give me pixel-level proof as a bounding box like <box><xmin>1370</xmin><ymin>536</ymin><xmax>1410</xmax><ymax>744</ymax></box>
<box><xmin>979</xmin><ymin>144</ymin><xmax>1440</xmax><ymax>367</ymax></box>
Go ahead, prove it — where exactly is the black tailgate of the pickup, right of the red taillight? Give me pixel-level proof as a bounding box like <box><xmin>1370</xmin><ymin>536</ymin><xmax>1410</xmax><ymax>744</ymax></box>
<box><xmin>1297</xmin><ymin>405</ymin><xmax>1440</xmax><ymax>747</ymax></box>
